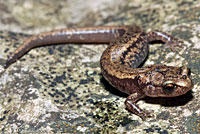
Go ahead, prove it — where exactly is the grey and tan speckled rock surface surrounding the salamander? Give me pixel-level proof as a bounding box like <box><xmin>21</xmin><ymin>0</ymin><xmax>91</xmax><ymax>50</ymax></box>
<box><xmin>0</xmin><ymin>0</ymin><xmax>200</xmax><ymax>134</ymax></box>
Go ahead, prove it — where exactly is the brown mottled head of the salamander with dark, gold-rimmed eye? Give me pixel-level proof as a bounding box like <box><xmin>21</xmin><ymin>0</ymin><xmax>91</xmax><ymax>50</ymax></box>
<box><xmin>139</xmin><ymin>65</ymin><xmax>193</xmax><ymax>97</ymax></box>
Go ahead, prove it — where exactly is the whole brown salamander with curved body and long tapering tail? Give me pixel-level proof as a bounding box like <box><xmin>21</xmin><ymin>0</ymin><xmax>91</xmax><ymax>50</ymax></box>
<box><xmin>4</xmin><ymin>26</ymin><xmax>193</xmax><ymax>119</ymax></box>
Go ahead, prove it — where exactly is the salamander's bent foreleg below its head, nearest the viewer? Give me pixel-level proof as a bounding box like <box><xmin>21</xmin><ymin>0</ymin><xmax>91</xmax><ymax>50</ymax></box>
<box><xmin>125</xmin><ymin>92</ymin><xmax>152</xmax><ymax>120</ymax></box>
